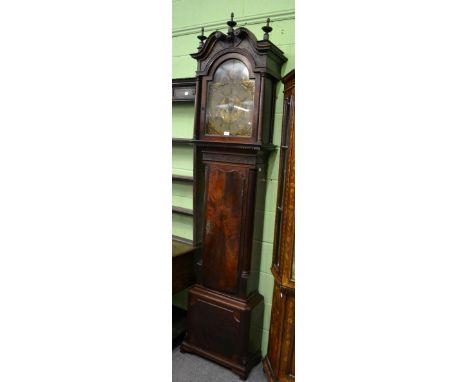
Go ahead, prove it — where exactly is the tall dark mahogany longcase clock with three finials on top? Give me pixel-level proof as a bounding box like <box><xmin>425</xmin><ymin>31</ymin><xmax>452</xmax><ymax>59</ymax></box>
<box><xmin>181</xmin><ymin>14</ymin><xmax>286</xmax><ymax>379</ymax></box>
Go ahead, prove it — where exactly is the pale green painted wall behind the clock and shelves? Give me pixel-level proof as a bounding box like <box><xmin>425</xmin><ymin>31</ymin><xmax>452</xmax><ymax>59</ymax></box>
<box><xmin>172</xmin><ymin>0</ymin><xmax>295</xmax><ymax>355</ymax></box>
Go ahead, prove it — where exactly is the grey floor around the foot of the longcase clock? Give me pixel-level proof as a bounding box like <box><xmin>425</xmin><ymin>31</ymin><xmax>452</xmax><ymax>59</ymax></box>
<box><xmin>172</xmin><ymin>346</ymin><xmax>267</xmax><ymax>382</ymax></box>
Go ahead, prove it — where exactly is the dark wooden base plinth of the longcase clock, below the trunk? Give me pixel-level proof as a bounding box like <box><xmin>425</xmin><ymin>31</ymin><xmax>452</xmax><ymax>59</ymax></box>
<box><xmin>180</xmin><ymin>285</ymin><xmax>263</xmax><ymax>379</ymax></box>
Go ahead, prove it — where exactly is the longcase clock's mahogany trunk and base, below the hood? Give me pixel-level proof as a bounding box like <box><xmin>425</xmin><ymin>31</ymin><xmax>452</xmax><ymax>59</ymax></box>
<box><xmin>181</xmin><ymin>144</ymin><xmax>266</xmax><ymax>379</ymax></box>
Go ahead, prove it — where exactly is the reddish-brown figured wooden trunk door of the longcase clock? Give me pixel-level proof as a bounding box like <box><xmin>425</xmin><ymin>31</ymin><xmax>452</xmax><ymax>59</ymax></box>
<box><xmin>203</xmin><ymin>162</ymin><xmax>249</xmax><ymax>293</ymax></box>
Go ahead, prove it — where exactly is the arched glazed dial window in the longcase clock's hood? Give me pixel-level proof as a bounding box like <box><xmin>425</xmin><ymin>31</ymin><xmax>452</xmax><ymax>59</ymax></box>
<box><xmin>205</xmin><ymin>59</ymin><xmax>255</xmax><ymax>137</ymax></box>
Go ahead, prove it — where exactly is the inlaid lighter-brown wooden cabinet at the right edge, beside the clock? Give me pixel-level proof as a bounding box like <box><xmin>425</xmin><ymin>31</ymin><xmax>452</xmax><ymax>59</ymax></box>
<box><xmin>263</xmin><ymin>70</ymin><xmax>295</xmax><ymax>381</ymax></box>
